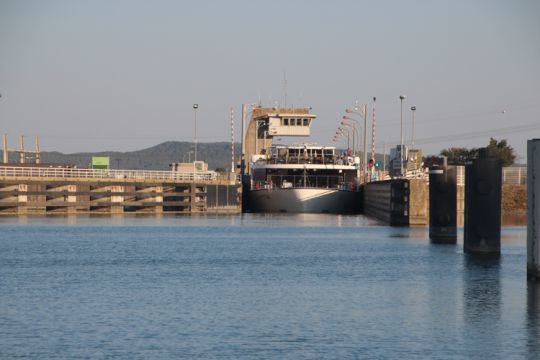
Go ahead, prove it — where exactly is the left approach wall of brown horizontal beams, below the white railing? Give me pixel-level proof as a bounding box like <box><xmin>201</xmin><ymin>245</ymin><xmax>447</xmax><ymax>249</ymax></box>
<box><xmin>0</xmin><ymin>178</ymin><xmax>240</xmax><ymax>215</ymax></box>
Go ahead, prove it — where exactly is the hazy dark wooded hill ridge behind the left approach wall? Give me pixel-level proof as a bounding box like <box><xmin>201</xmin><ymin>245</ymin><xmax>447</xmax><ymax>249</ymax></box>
<box><xmin>0</xmin><ymin>141</ymin><xmax>240</xmax><ymax>170</ymax></box>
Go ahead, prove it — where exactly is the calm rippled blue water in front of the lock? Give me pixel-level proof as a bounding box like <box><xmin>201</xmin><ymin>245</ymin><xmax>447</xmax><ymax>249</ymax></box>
<box><xmin>0</xmin><ymin>214</ymin><xmax>540</xmax><ymax>359</ymax></box>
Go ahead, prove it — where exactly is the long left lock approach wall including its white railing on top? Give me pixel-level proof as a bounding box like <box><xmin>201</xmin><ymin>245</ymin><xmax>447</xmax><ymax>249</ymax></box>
<box><xmin>0</xmin><ymin>164</ymin><xmax>240</xmax><ymax>215</ymax></box>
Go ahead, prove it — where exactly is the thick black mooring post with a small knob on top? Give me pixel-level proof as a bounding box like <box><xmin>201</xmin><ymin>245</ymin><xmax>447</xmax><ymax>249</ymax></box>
<box><xmin>463</xmin><ymin>149</ymin><xmax>502</xmax><ymax>255</ymax></box>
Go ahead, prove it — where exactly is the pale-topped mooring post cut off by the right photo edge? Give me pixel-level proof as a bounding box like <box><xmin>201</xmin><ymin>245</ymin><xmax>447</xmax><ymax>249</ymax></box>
<box><xmin>527</xmin><ymin>139</ymin><xmax>540</xmax><ymax>280</ymax></box>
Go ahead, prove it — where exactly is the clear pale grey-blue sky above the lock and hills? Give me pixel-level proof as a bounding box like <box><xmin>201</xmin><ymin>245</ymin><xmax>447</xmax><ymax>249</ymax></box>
<box><xmin>0</xmin><ymin>0</ymin><xmax>540</xmax><ymax>162</ymax></box>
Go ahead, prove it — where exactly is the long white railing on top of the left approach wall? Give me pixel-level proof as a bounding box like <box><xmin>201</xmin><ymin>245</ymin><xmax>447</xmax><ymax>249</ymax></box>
<box><xmin>0</xmin><ymin>166</ymin><xmax>218</xmax><ymax>181</ymax></box>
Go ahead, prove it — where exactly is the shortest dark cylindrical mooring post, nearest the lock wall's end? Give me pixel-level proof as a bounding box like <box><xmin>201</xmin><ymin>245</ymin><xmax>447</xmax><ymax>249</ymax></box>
<box><xmin>429</xmin><ymin>166</ymin><xmax>457</xmax><ymax>244</ymax></box>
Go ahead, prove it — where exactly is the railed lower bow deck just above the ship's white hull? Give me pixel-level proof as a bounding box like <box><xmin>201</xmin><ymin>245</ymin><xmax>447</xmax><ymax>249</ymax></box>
<box><xmin>251</xmin><ymin>175</ymin><xmax>357</xmax><ymax>190</ymax></box>
